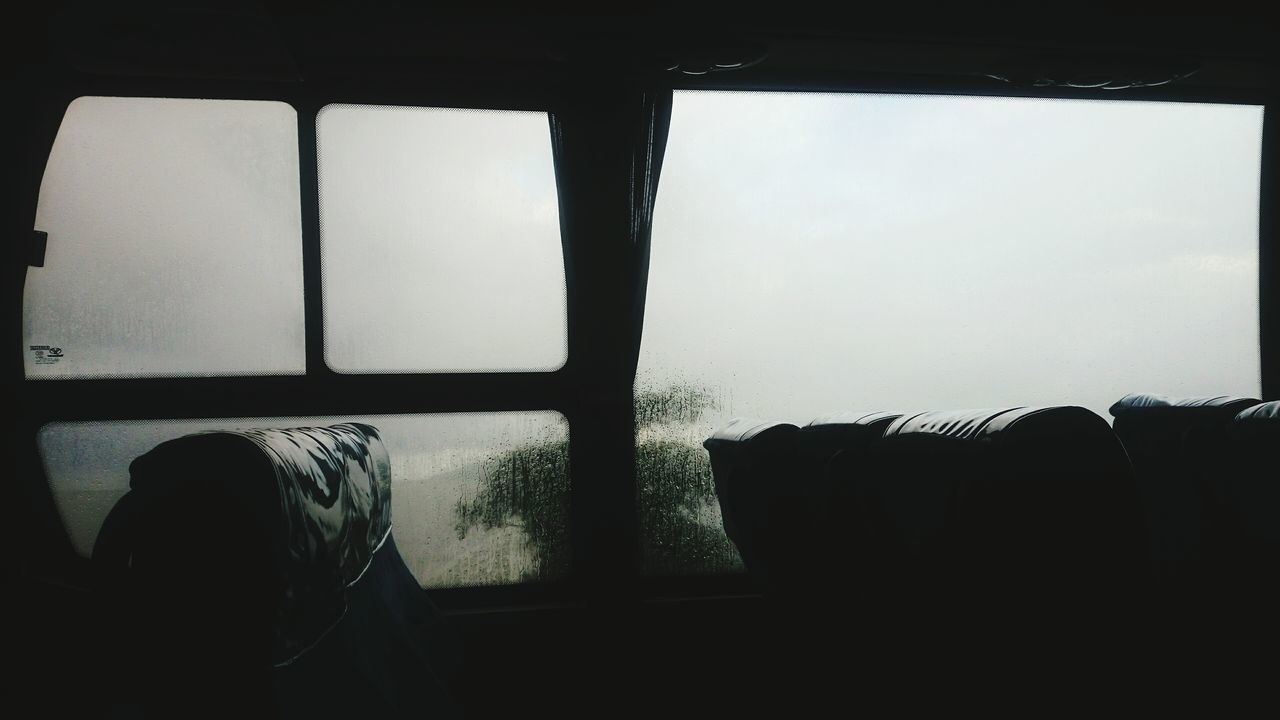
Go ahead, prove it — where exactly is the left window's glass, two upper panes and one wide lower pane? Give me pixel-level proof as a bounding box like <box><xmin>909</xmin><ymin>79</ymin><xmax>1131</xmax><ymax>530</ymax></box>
<box><xmin>23</xmin><ymin>97</ymin><xmax>571</xmax><ymax>587</ymax></box>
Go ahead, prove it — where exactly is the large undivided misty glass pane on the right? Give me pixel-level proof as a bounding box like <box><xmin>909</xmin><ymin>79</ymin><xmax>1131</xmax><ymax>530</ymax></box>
<box><xmin>637</xmin><ymin>91</ymin><xmax>1262</xmax><ymax>571</ymax></box>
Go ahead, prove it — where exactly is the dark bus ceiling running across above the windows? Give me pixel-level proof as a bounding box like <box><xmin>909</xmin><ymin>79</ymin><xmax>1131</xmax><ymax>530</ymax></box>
<box><xmin>10</xmin><ymin>1</ymin><xmax>1280</xmax><ymax>96</ymax></box>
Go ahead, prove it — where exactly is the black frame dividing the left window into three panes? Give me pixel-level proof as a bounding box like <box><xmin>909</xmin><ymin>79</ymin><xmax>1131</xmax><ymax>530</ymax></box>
<box><xmin>10</xmin><ymin>78</ymin><xmax>595</xmax><ymax>609</ymax></box>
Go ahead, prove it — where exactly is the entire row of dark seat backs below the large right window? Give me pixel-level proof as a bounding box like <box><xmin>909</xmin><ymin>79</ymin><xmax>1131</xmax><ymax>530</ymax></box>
<box><xmin>705</xmin><ymin>395</ymin><xmax>1280</xmax><ymax>594</ymax></box>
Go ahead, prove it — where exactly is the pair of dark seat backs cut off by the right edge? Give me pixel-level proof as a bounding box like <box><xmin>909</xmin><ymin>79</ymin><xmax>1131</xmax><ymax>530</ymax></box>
<box><xmin>1111</xmin><ymin>393</ymin><xmax>1280</xmax><ymax>585</ymax></box>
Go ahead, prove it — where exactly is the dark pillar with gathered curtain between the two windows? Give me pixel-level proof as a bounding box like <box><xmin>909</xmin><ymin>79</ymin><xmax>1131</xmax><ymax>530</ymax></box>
<box><xmin>550</xmin><ymin>73</ymin><xmax>671</xmax><ymax>622</ymax></box>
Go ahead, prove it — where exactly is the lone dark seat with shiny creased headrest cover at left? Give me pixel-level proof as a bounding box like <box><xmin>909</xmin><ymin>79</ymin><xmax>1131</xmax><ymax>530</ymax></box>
<box><xmin>95</xmin><ymin>423</ymin><xmax>457</xmax><ymax>717</ymax></box>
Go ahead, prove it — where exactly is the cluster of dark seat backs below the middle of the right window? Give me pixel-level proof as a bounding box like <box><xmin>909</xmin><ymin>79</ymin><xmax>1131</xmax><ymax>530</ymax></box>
<box><xmin>705</xmin><ymin>406</ymin><xmax>1140</xmax><ymax>593</ymax></box>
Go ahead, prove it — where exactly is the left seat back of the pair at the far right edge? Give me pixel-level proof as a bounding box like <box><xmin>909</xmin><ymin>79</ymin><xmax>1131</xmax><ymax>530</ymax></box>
<box><xmin>1111</xmin><ymin>393</ymin><xmax>1261</xmax><ymax>579</ymax></box>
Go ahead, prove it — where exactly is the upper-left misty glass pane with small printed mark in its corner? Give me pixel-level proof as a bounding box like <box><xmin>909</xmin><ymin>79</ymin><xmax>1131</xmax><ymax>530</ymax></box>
<box><xmin>23</xmin><ymin>97</ymin><xmax>306</xmax><ymax>378</ymax></box>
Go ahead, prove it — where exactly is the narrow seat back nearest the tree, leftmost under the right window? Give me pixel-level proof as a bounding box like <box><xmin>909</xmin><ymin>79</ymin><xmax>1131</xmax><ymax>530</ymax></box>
<box><xmin>703</xmin><ymin>418</ymin><xmax>801</xmax><ymax>583</ymax></box>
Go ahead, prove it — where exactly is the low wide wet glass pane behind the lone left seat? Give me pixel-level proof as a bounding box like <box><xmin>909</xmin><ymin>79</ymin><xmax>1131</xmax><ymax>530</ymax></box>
<box><xmin>40</xmin><ymin>411</ymin><xmax>570</xmax><ymax>587</ymax></box>
